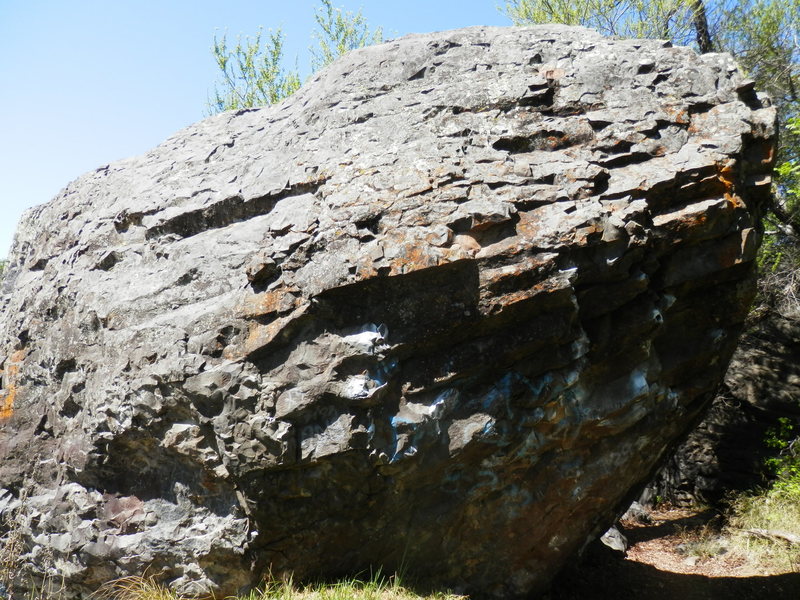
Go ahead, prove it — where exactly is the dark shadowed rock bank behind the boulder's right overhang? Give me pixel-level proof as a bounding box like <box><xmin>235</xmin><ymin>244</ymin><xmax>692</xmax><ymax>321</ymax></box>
<box><xmin>647</xmin><ymin>310</ymin><xmax>800</xmax><ymax>506</ymax></box>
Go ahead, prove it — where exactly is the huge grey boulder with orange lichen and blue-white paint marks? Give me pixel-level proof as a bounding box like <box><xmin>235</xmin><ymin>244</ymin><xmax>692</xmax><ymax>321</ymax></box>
<box><xmin>0</xmin><ymin>26</ymin><xmax>774</xmax><ymax>597</ymax></box>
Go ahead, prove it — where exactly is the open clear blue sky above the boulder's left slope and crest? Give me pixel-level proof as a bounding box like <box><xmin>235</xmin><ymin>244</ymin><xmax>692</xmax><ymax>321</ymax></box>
<box><xmin>0</xmin><ymin>0</ymin><xmax>509</xmax><ymax>258</ymax></box>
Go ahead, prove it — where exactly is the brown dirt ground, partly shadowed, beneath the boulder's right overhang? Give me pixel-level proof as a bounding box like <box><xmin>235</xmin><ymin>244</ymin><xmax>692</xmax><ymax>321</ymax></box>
<box><xmin>547</xmin><ymin>510</ymin><xmax>800</xmax><ymax>600</ymax></box>
